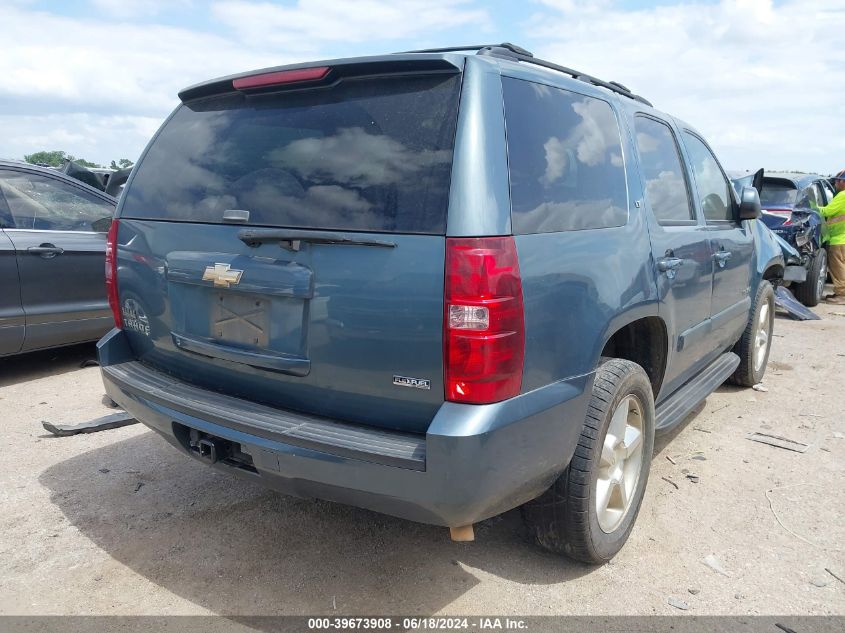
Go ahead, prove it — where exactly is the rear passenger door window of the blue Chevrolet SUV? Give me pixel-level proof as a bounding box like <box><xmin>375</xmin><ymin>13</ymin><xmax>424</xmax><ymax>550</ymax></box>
<box><xmin>635</xmin><ymin>116</ymin><xmax>695</xmax><ymax>224</ymax></box>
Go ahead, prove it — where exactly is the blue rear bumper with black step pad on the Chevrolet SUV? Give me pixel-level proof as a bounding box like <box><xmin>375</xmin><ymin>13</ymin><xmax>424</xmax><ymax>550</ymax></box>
<box><xmin>98</xmin><ymin>330</ymin><xmax>593</xmax><ymax>526</ymax></box>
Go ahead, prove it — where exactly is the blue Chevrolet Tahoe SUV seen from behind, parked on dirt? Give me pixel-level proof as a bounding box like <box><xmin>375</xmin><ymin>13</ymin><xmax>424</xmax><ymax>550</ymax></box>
<box><xmin>99</xmin><ymin>44</ymin><xmax>783</xmax><ymax>562</ymax></box>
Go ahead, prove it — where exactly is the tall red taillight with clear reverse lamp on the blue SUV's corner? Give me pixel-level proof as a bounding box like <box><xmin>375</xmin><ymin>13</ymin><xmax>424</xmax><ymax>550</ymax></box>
<box><xmin>443</xmin><ymin>237</ymin><xmax>525</xmax><ymax>404</ymax></box>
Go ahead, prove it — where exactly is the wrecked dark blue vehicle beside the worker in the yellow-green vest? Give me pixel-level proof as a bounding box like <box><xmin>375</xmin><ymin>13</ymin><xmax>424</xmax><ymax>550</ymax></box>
<box><xmin>732</xmin><ymin>172</ymin><xmax>834</xmax><ymax>307</ymax></box>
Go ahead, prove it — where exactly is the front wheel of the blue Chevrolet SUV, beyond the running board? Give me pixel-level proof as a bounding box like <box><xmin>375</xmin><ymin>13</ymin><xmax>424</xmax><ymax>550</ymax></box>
<box><xmin>728</xmin><ymin>280</ymin><xmax>775</xmax><ymax>387</ymax></box>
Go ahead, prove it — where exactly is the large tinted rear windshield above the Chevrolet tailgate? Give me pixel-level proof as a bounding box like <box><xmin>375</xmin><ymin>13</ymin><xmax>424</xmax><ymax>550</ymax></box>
<box><xmin>121</xmin><ymin>74</ymin><xmax>460</xmax><ymax>234</ymax></box>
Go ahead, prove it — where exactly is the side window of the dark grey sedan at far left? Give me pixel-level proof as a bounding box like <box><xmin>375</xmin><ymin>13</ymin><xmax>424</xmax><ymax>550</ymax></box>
<box><xmin>0</xmin><ymin>170</ymin><xmax>114</xmax><ymax>231</ymax></box>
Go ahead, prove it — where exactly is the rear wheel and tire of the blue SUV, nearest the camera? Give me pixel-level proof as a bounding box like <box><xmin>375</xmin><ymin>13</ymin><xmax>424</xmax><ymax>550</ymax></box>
<box><xmin>522</xmin><ymin>359</ymin><xmax>654</xmax><ymax>563</ymax></box>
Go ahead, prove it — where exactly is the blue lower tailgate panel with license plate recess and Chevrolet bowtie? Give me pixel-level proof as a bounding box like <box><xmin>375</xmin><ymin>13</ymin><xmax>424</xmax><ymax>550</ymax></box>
<box><xmin>118</xmin><ymin>219</ymin><xmax>444</xmax><ymax>432</ymax></box>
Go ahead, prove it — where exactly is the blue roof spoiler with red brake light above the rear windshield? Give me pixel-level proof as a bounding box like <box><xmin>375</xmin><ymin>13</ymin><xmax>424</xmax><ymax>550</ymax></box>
<box><xmin>179</xmin><ymin>54</ymin><xmax>464</xmax><ymax>103</ymax></box>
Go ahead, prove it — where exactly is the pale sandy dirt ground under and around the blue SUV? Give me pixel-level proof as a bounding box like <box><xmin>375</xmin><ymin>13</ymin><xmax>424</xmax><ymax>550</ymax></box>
<box><xmin>0</xmin><ymin>306</ymin><xmax>845</xmax><ymax>615</ymax></box>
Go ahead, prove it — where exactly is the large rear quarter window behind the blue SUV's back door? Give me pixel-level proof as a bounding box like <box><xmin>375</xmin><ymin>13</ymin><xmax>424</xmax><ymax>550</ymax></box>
<box><xmin>502</xmin><ymin>77</ymin><xmax>628</xmax><ymax>234</ymax></box>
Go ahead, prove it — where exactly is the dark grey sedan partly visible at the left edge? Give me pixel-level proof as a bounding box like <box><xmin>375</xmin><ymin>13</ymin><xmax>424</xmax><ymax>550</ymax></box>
<box><xmin>0</xmin><ymin>161</ymin><xmax>116</xmax><ymax>355</ymax></box>
